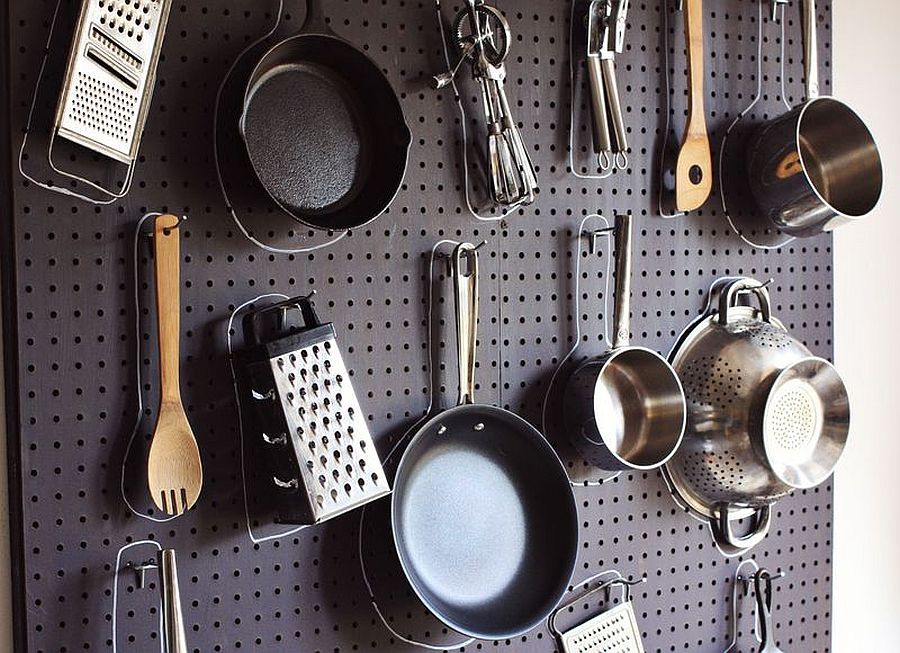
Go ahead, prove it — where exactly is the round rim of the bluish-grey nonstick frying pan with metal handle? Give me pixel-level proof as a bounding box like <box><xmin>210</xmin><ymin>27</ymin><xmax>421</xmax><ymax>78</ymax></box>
<box><xmin>391</xmin><ymin>404</ymin><xmax>580</xmax><ymax>641</ymax></box>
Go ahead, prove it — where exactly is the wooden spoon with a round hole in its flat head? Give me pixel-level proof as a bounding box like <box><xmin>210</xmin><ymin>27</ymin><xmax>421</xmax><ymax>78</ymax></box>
<box><xmin>675</xmin><ymin>0</ymin><xmax>713</xmax><ymax>212</ymax></box>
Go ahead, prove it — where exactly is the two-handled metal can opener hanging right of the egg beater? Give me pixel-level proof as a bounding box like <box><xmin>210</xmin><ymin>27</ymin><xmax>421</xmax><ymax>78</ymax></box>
<box><xmin>587</xmin><ymin>0</ymin><xmax>630</xmax><ymax>172</ymax></box>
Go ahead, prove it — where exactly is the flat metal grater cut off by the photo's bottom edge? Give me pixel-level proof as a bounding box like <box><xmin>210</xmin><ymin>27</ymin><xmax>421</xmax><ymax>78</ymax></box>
<box><xmin>550</xmin><ymin>579</ymin><xmax>644</xmax><ymax>653</ymax></box>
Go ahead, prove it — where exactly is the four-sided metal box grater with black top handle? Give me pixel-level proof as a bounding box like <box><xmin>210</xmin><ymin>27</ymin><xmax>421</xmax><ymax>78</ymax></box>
<box><xmin>236</xmin><ymin>297</ymin><xmax>390</xmax><ymax>524</ymax></box>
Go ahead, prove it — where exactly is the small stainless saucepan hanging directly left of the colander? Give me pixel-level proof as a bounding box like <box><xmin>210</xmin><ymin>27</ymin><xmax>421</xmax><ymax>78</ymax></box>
<box><xmin>563</xmin><ymin>215</ymin><xmax>686</xmax><ymax>471</ymax></box>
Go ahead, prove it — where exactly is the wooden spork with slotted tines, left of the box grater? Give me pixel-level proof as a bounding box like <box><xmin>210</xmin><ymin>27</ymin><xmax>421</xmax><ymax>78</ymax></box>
<box><xmin>147</xmin><ymin>215</ymin><xmax>203</xmax><ymax>515</ymax></box>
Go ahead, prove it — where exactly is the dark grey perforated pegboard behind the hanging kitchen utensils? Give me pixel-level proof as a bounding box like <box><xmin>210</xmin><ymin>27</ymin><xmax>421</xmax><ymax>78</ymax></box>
<box><xmin>3</xmin><ymin>0</ymin><xmax>832</xmax><ymax>653</ymax></box>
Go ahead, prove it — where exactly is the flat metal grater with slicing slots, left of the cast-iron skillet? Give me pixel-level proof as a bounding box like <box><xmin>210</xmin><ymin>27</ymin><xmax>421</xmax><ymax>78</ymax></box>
<box><xmin>55</xmin><ymin>0</ymin><xmax>172</xmax><ymax>164</ymax></box>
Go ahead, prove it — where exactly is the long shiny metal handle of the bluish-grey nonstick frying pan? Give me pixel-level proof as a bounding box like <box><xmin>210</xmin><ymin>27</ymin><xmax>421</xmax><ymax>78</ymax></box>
<box><xmin>452</xmin><ymin>243</ymin><xmax>478</xmax><ymax>406</ymax></box>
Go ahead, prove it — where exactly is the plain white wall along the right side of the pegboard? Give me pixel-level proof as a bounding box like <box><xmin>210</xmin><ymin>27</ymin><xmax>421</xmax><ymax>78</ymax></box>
<box><xmin>833</xmin><ymin>0</ymin><xmax>900</xmax><ymax>653</ymax></box>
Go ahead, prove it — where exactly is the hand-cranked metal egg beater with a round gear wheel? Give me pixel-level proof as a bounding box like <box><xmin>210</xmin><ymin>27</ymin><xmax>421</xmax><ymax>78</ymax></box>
<box><xmin>434</xmin><ymin>0</ymin><xmax>538</xmax><ymax>206</ymax></box>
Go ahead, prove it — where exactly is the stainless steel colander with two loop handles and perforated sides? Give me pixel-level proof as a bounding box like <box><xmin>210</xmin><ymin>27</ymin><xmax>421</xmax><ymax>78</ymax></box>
<box><xmin>665</xmin><ymin>277</ymin><xmax>850</xmax><ymax>554</ymax></box>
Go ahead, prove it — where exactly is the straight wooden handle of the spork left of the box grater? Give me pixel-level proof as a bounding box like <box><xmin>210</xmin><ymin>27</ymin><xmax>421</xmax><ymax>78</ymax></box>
<box><xmin>153</xmin><ymin>215</ymin><xmax>181</xmax><ymax>403</ymax></box>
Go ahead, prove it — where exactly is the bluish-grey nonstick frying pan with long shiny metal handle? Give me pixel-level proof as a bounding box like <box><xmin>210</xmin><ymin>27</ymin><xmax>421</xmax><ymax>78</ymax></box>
<box><xmin>391</xmin><ymin>244</ymin><xmax>578</xmax><ymax>640</ymax></box>
